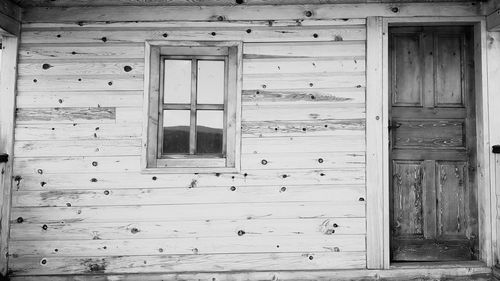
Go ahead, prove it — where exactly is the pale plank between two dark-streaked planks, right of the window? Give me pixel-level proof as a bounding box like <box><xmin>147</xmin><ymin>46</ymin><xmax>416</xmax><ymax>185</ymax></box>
<box><xmin>242</xmin><ymin>104</ymin><xmax>365</xmax><ymax>122</ymax></box>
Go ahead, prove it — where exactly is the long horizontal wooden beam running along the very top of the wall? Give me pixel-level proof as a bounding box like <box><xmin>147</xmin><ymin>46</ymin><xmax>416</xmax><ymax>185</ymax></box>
<box><xmin>23</xmin><ymin>2</ymin><xmax>482</xmax><ymax>22</ymax></box>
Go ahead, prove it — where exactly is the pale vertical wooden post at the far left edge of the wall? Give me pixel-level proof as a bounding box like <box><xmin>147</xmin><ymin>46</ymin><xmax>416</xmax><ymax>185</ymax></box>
<box><xmin>0</xmin><ymin>34</ymin><xmax>18</xmax><ymax>275</ymax></box>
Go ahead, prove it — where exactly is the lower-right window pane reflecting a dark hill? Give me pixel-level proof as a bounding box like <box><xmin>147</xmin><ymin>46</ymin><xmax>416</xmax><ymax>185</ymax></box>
<box><xmin>196</xmin><ymin>110</ymin><xmax>224</xmax><ymax>154</ymax></box>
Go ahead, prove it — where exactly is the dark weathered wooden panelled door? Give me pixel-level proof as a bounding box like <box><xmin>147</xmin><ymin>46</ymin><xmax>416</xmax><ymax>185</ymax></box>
<box><xmin>389</xmin><ymin>27</ymin><xmax>478</xmax><ymax>261</ymax></box>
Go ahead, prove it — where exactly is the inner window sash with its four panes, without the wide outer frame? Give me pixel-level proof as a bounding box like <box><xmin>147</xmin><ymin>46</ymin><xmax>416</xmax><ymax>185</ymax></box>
<box><xmin>158</xmin><ymin>56</ymin><xmax>228</xmax><ymax>159</ymax></box>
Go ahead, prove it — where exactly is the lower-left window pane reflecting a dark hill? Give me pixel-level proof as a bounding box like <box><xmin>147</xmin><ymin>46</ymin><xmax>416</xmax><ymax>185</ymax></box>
<box><xmin>163</xmin><ymin>110</ymin><xmax>190</xmax><ymax>154</ymax></box>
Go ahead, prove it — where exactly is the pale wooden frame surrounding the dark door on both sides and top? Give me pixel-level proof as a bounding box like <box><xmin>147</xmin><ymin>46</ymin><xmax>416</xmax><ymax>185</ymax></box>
<box><xmin>366</xmin><ymin>17</ymin><xmax>497</xmax><ymax>269</ymax></box>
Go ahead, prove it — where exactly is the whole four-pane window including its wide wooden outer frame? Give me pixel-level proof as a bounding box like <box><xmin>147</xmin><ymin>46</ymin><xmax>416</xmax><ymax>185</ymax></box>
<box><xmin>143</xmin><ymin>42</ymin><xmax>241</xmax><ymax>173</ymax></box>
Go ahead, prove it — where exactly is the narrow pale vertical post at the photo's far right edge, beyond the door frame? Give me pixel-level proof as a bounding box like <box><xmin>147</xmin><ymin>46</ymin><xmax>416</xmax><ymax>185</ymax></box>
<box><xmin>486</xmin><ymin>32</ymin><xmax>500</xmax><ymax>264</ymax></box>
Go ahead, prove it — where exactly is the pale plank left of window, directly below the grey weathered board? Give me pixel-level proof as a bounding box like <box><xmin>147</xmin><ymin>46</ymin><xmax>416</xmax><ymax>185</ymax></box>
<box><xmin>15</xmin><ymin>123</ymin><xmax>142</xmax><ymax>141</ymax></box>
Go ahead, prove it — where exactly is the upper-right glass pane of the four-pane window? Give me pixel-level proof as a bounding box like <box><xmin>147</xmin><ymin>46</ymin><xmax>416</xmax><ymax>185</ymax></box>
<box><xmin>197</xmin><ymin>60</ymin><xmax>224</xmax><ymax>104</ymax></box>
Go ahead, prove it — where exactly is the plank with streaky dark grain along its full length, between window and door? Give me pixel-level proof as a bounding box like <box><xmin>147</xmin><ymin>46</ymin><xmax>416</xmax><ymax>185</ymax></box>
<box><xmin>241</xmin><ymin>119</ymin><xmax>365</xmax><ymax>138</ymax></box>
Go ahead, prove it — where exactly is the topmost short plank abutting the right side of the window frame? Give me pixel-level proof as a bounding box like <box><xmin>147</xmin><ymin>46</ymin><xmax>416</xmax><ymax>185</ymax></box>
<box><xmin>243</xmin><ymin>41</ymin><xmax>366</xmax><ymax>60</ymax></box>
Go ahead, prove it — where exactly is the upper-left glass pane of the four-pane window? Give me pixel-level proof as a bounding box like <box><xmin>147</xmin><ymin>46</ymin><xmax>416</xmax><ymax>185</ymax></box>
<box><xmin>163</xmin><ymin>60</ymin><xmax>191</xmax><ymax>103</ymax></box>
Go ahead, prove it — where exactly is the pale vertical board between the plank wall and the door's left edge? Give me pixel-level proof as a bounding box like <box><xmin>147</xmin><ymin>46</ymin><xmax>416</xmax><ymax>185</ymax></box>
<box><xmin>366</xmin><ymin>17</ymin><xmax>388</xmax><ymax>269</ymax></box>
